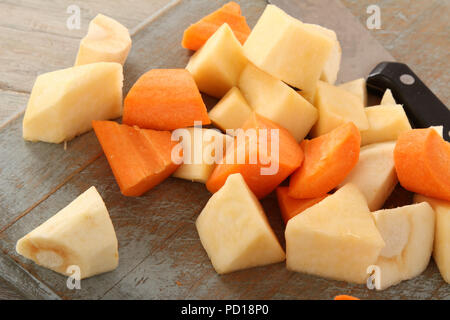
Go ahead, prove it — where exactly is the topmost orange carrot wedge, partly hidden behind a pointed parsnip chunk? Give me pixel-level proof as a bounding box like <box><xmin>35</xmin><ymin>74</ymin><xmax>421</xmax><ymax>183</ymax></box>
<box><xmin>181</xmin><ymin>1</ymin><xmax>251</xmax><ymax>51</ymax></box>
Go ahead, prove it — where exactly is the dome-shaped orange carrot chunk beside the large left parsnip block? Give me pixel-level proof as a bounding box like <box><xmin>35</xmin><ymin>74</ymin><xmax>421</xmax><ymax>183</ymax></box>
<box><xmin>123</xmin><ymin>69</ymin><xmax>211</xmax><ymax>130</ymax></box>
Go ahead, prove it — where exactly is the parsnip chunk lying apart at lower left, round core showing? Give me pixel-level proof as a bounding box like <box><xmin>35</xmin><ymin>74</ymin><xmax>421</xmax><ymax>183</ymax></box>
<box><xmin>16</xmin><ymin>187</ymin><xmax>119</xmax><ymax>279</ymax></box>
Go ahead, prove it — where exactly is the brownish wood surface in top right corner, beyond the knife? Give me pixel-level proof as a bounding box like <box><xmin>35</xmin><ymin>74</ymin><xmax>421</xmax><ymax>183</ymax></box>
<box><xmin>341</xmin><ymin>0</ymin><xmax>450</xmax><ymax>106</ymax></box>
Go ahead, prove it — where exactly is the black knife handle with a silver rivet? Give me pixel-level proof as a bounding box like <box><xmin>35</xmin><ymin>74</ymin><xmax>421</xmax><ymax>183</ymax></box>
<box><xmin>367</xmin><ymin>62</ymin><xmax>450</xmax><ymax>141</ymax></box>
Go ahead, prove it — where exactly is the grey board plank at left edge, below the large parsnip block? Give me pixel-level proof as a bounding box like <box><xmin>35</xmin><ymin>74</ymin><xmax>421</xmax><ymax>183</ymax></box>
<box><xmin>0</xmin><ymin>116</ymin><xmax>101</xmax><ymax>230</ymax></box>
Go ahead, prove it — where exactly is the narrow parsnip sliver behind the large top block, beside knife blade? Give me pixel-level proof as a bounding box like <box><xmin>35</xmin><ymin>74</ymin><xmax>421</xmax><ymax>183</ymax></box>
<box><xmin>305</xmin><ymin>23</ymin><xmax>342</xmax><ymax>84</ymax></box>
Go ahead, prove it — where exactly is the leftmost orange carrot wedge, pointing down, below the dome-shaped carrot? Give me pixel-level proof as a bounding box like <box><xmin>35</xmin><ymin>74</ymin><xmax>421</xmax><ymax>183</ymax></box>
<box><xmin>92</xmin><ymin>121</ymin><xmax>179</xmax><ymax>197</ymax></box>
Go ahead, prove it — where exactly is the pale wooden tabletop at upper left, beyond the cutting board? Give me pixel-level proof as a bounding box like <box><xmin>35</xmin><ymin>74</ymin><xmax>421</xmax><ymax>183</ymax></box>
<box><xmin>0</xmin><ymin>0</ymin><xmax>179</xmax><ymax>92</ymax></box>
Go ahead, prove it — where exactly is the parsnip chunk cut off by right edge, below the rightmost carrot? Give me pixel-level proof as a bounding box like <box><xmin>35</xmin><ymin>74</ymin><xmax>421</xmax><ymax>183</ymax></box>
<box><xmin>414</xmin><ymin>194</ymin><xmax>450</xmax><ymax>283</ymax></box>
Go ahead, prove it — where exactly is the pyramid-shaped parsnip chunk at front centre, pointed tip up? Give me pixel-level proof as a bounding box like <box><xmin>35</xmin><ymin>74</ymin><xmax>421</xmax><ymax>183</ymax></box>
<box><xmin>196</xmin><ymin>173</ymin><xmax>285</xmax><ymax>274</ymax></box>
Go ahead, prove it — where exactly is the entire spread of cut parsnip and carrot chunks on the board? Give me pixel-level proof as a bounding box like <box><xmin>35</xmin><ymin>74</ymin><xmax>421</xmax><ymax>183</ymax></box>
<box><xmin>17</xmin><ymin>2</ymin><xmax>450</xmax><ymax>289</ymax></box>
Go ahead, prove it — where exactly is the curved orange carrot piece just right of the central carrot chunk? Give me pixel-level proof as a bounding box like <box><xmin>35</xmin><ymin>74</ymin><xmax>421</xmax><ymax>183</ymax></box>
<box><xmin>289</xmin><ymin>122</ymin><xmax>361</xmax><ymax>199</ymax></box>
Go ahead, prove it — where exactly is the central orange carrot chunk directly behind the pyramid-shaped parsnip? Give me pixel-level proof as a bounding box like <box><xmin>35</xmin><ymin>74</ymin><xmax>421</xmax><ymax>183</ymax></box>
<box><xmin>206</xmin><ymin>113</ymin><xmax>303</xmax><ymax>199</ymax></box>
